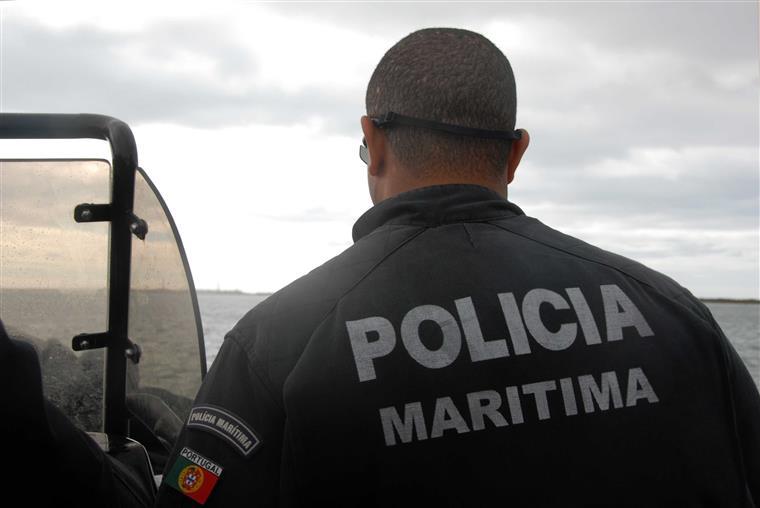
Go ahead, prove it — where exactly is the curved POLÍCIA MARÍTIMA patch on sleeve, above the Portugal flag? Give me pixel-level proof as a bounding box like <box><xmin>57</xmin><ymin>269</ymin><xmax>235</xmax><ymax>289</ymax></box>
<box><xmin>187</xmin><ymin>404</ymin><xmax>261</xmax><ymax>457</ymax></box>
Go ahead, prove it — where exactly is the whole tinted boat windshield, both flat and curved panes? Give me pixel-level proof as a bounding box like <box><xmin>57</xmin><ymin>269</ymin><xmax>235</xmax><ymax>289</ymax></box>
<box><xmin>0</xmin><ymin>159</ymin><xmax>205</xmax><ymax>432</ymax></box>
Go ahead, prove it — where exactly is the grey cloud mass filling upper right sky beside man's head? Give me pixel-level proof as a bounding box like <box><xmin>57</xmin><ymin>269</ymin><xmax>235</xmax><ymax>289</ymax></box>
<box><xmin>273</xmin><ymin>2</ymin><xmax>759</xmax><ymax>154</ymax></box>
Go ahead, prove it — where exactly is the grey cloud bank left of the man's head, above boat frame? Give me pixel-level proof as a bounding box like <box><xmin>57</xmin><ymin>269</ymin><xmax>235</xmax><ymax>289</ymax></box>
<box><xmin>2</xmin><ymin>21</ymin><xmax>361</xmax><ymax>133</ymax></box>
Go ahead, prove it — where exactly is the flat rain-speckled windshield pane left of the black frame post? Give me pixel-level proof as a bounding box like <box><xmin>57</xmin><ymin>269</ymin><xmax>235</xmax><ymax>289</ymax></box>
<box><xmin>0</xmin><ymin>160</ymin><xmax>111</xmax><ymax>431</ymax></box>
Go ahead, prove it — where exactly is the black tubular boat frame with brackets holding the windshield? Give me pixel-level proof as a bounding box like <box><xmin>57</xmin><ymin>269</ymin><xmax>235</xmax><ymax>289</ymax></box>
<box><xmin>0</xmin><ymin>113</ymin><xmax>206</xmax><ymax>436</ymax></box>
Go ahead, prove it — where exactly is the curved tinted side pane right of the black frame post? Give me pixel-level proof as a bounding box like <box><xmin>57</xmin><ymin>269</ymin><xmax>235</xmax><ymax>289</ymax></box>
<box><xmin>127</xmin><ymin>172</ymin><xmax>205</xmax><ymax>420</ymax></box>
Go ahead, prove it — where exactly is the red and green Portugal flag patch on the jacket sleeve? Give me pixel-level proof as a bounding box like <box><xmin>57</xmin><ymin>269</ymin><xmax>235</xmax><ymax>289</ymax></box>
<box><xmin>164</xmin><ymin>447</ymin><xmax>222</xmax><ymax>504</ymax></box>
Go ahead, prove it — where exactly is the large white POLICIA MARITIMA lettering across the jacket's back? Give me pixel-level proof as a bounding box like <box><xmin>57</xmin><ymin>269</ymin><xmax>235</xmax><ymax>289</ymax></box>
<box><xmin>346</xmin><ymin>284</ymin><xmax>658</xmax><ymax>446</ymax></box>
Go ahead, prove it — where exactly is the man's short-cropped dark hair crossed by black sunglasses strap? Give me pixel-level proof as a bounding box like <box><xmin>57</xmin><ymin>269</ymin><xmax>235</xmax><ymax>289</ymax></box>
<box><xmin>366</xmin><ymin>28</ymin><xmax>517</xmax><ymax>179</ymax></box>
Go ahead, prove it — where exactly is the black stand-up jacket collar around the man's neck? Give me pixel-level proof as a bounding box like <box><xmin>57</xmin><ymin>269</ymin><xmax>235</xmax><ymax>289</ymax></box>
<box><xmin>352</xmin><ymin>184</ymin><xmax>524</xmax><ymax>242</ymax></box>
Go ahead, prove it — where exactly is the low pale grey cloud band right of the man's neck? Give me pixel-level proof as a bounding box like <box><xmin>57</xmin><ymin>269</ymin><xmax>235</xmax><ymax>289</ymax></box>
<box><xmin>510</xmin><ymin>161</ymin><xmax>760</xmax><ymax>236</ymax></box>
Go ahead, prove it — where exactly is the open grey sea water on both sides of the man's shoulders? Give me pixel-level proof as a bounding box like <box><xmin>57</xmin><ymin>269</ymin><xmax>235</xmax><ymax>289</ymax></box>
<box><xmin>198</xmin><ymin>292</ymin><xmax>760</xmax><ymax>386</ymax></box>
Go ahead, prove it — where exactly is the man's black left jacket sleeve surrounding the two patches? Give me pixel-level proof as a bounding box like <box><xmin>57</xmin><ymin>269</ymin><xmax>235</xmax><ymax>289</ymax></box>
<box><xmin>157</xmin><ymin>332</ymin><xmax>284</xmax><ymax>507</ymax></box>
